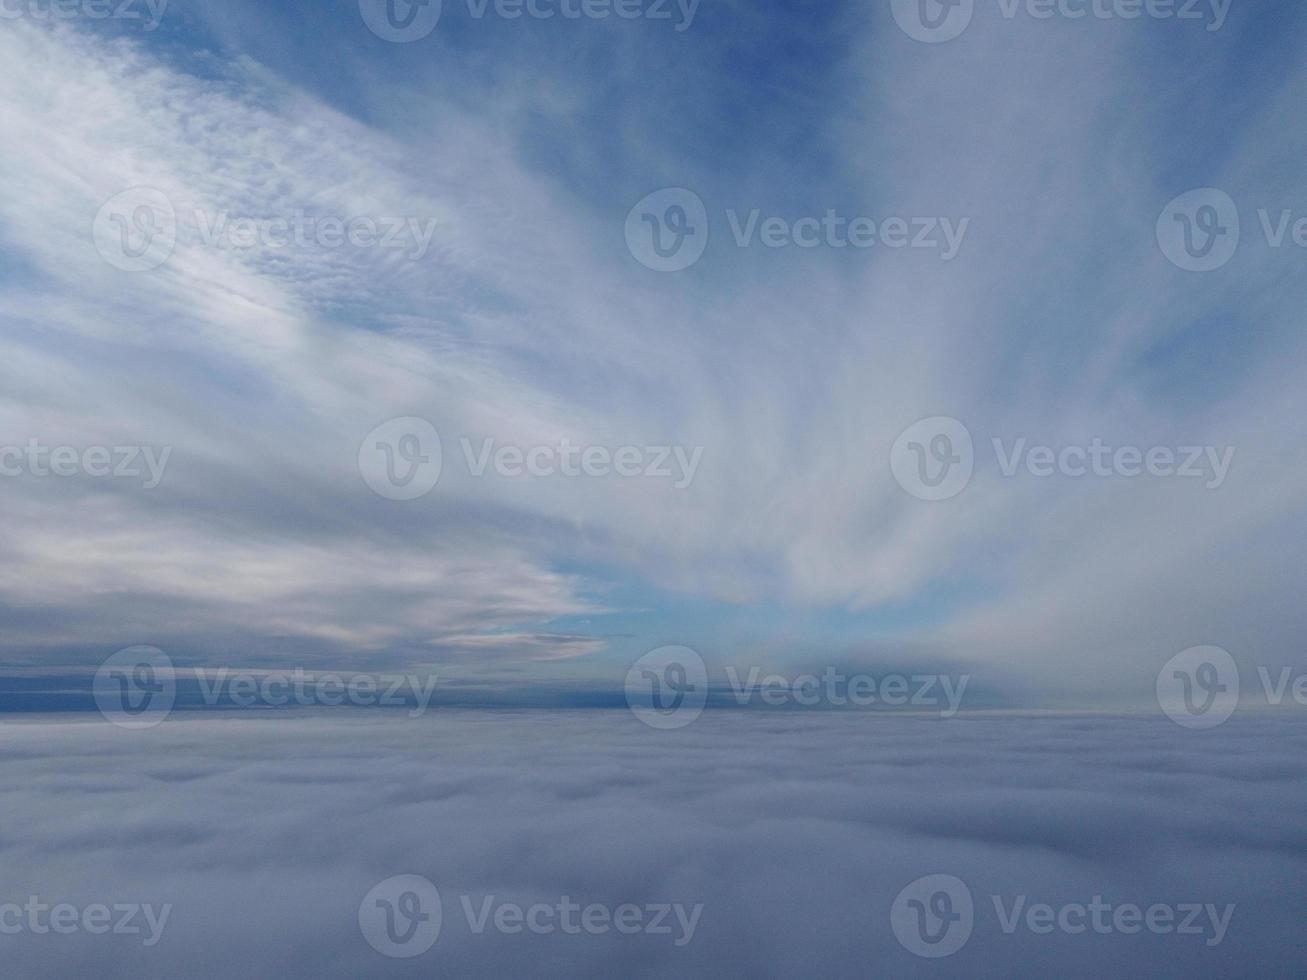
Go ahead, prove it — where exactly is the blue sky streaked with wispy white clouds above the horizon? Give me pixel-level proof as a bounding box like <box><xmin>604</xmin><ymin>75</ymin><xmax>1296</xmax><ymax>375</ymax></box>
<box><xmin>0</xmin><ymin>0</ymin><xmax>1307</xmax><ymax>707</ymax></box>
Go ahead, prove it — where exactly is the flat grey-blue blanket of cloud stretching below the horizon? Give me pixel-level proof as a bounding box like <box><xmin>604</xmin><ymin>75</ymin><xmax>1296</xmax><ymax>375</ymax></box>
<box><xmin>0</xmin><ymin>710</ymin><xmax>1307</xmax><ymax>980</ymax></box>
